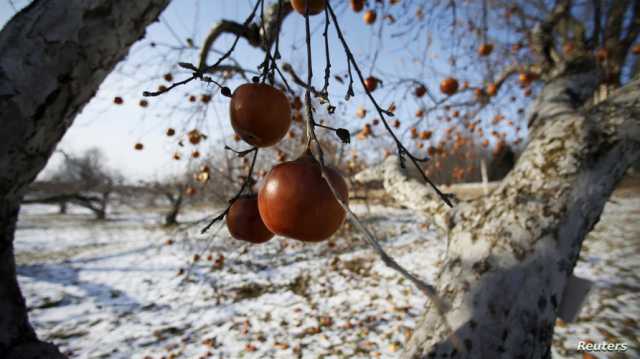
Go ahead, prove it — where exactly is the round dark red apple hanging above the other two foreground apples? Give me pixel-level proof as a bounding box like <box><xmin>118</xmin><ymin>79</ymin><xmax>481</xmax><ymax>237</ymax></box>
<box><xmin>229</xmin><ymin>83</ymin><xmax>291</xmax><ymax>147</ymax></box>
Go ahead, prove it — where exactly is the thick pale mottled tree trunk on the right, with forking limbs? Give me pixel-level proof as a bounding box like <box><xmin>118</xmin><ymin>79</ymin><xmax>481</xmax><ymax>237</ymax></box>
<box><xmin>362</xmin><ymin>64</ymin><xmax>640</xmax><ymax>358</ymax></box>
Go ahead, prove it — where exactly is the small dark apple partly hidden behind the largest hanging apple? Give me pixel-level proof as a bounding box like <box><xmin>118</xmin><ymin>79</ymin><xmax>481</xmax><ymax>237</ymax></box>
<box><xmin>227</xmin><ymin>195</ymin><xmax>273</xmax><ymax>243</ymax></box>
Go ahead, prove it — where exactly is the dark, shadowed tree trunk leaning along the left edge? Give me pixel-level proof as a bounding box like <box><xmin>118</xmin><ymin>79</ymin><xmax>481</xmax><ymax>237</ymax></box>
<box><xmin>0</xmin><ymin>0</ymin><xmax>168</xmax><ymax>359</ymax></box>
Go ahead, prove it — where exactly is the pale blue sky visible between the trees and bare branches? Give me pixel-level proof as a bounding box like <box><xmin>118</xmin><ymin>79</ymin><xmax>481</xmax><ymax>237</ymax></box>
<box><xmin>0</xmin><ymin>0</ymin><xmax>536</xmax><ymax>181</ymax></box>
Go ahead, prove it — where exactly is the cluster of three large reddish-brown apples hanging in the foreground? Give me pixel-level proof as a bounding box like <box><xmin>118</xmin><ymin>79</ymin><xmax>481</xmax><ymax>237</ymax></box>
<box><xmin>226</xmin><ymin>83</ymin><xmax>348</xmax><ymax>243</ymax></box>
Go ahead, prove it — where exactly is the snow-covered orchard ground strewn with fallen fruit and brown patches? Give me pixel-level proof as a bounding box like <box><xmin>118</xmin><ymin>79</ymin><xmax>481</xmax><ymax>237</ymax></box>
<box><xmin>15</xmin><ymin>181</ymin><xmax>640</xmax><ymax>358</ymax></box>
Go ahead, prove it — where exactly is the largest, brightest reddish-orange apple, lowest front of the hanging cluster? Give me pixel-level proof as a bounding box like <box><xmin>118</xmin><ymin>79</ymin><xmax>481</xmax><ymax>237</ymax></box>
<box><xmin>258</xmin><ymin>153</ymin><xmax>348</xmax><ymax>242</ymax></box>
